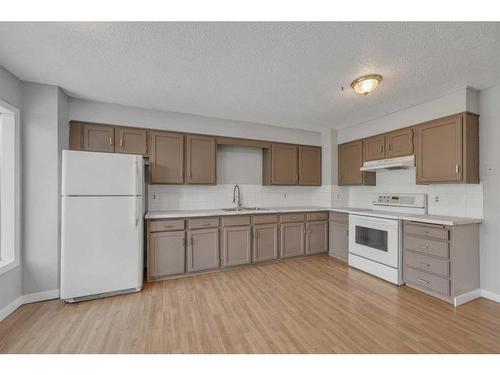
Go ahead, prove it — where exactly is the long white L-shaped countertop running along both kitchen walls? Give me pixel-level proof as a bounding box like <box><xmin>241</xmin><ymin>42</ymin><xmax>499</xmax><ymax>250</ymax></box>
<box><xmin>145</xmin><ymin>206</ymin><xmax>482</xmax><ymax>225</ymax></box>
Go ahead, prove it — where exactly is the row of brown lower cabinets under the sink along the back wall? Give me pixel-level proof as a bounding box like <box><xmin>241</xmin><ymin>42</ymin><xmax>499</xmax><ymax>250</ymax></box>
<box><xmin>146</xmin><ymin>211</ymin><xmax>329</xmax><ymax>281</ymax></box>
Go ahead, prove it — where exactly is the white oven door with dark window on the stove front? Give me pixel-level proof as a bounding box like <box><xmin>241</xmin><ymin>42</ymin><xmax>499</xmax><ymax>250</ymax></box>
<box><xmin>349</xmin><ymin>215</ymin><xmax>399</xmax><ymax>268</ymax></box>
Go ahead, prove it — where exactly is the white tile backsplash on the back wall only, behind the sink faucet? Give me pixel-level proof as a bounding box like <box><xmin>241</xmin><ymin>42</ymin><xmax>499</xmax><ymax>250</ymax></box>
<box><xmin>148</xmin><ymin>184</ymin><xmax>332</xmax><ymax>211</ymax></box>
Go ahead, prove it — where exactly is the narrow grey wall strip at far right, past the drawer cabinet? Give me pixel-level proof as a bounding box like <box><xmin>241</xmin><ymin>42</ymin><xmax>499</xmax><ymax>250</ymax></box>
<box><xmin>479</xmin><ymin>85</ymin><xmax>500</xmax><ymax>298</ymax></box>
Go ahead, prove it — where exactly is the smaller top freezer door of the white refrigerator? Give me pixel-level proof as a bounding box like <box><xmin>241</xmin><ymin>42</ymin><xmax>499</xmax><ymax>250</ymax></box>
<box><xmin>62</xmin><ymin>150</ymin><xmax>144</xmax><ymax>196</ymax></box>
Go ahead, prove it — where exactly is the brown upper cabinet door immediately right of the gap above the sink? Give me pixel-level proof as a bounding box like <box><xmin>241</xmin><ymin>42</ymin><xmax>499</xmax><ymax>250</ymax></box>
<box><xmin>271</xmin><ymin>143</ymin><xmax>298</xmax><ymax>185</ymax></box>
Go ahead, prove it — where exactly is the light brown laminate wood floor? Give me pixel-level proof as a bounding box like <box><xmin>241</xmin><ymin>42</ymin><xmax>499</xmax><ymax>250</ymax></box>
<box><xmin>0</xmin><ymin>256</ymin><xmax>500</xmax><ymax>353</ymax></box>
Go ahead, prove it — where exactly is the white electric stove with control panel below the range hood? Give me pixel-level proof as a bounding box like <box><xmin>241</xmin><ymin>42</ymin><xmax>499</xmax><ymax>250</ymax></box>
<box><xmin>349</xmin><ymin>194</ymin><xmax>427</xmax><ymax>285</ymax></box>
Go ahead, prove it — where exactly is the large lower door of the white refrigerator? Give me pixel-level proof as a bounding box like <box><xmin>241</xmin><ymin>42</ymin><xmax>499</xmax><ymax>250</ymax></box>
<box><xmin>61</xmin><ymin>197</ymin><xmax>143</xmax><ymax>299</ymax></box>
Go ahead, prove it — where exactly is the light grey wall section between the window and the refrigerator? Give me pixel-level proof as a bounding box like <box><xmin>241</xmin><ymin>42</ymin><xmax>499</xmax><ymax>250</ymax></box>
<box><xmin>22</xmin><ymin>82</ymin><xmax>68</xmax><ymax>296</ymax></box>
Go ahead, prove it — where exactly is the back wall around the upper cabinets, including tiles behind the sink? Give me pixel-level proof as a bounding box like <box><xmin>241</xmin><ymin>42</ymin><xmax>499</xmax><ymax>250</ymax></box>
<box><xmin>69</xmin><ymin>98</ymin><xmax>336</xmax><ymax>210</ymax></box>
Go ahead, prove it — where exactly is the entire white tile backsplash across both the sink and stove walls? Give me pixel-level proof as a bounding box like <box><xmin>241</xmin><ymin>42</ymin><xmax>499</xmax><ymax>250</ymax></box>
<box><xmin>148</xmin><ymin>168</ymin><xmax>483</xmax><ymax>218</ymax></box>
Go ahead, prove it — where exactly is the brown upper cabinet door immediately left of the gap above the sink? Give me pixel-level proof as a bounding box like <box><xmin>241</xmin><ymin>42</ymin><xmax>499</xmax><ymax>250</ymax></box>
<box><xmin>186</xmin><ymin>135</ymin><xmax>217</xmax><ymax>184</ymax></box>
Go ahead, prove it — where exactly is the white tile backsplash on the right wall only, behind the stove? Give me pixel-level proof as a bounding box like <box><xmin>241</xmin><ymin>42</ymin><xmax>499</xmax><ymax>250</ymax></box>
<box><xmin>346</xmin><ymin>168</ymin><xmax>483</xmax><ymax>218</ymax></box>
